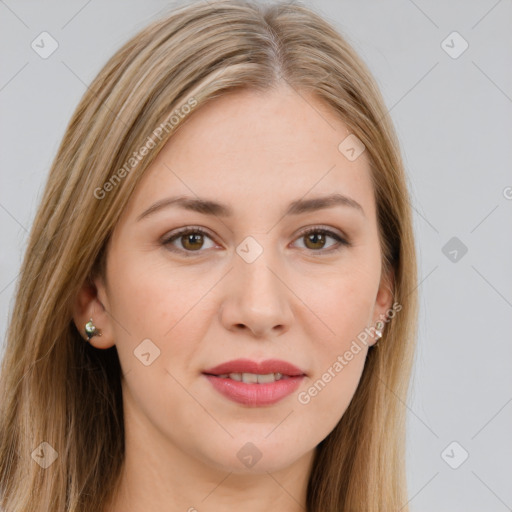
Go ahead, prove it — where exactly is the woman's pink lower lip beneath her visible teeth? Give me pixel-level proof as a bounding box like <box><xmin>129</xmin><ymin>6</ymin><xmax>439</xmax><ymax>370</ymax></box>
<box><xmin>203</xmin><ymin>374</ymin><xmax>304</xmax><ymax>407</ymax></box>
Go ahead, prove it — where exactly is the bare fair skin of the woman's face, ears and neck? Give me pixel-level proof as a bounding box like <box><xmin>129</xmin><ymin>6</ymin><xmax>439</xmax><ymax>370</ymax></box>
<box><xmin>74</xmin><ymin>86</ymin><xmax>392</xmax><ymax>512</ymax></box>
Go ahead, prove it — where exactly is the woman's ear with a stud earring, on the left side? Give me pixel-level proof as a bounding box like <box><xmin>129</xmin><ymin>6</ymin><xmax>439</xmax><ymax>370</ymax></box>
<box><xmin>73</xmin><ymin>277</ymin><xmax>115</xmax><ymax>349</ymax></box>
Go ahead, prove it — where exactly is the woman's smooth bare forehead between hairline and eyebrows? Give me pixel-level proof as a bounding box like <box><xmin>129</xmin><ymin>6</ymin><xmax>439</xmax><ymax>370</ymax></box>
<box><xmin>122</xmin><ymin>87</ymin><xmax>374</xmax><ymax>224</ymax></box>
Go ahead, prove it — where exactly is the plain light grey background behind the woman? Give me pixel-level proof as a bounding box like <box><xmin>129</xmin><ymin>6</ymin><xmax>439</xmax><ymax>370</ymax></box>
<box><xmin>0</xmin><ymin>0</ymin><xmax>512</xmax><ymax>512</ymax></box>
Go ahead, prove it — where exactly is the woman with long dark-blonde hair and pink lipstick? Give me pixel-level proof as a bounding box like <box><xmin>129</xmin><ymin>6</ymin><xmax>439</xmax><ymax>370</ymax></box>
<box><xmin>0</xmin><ymin>0</ymin><xmax>417</xmax><ymax>512</ymax></box>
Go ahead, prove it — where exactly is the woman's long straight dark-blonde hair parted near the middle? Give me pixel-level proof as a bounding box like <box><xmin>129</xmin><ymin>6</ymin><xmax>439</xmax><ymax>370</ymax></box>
<box><xmin>0</xmin><ymin>0</ymin><xmax>418</xmax><ymax>512</ymax></box>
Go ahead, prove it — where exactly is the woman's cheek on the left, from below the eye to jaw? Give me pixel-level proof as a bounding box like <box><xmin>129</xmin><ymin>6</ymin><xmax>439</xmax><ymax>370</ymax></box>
<box><xmin>105</xmin><ymin>255</ymin><xmax>211</xmax><ymax>416</ymax></box>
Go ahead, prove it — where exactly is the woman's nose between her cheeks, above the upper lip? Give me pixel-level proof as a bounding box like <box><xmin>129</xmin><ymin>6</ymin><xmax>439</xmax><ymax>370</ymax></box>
<box><xmin>220</xmin><ymin>245</ymin><xmax>293</xmax><ymax>338</ymax></box>
